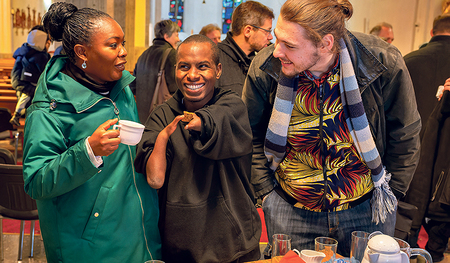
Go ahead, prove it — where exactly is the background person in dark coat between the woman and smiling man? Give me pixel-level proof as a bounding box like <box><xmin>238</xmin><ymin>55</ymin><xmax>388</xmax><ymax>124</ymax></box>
<box><xmin>130</xmin><ymin>20</ymin><xmax>180</xmax><ymax>123</ymax></box>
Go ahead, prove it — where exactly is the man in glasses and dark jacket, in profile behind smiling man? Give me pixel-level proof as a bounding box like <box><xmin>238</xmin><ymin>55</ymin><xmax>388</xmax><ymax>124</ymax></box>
<box><xmin>217</xmin><ymin>1</ymin><xmax>274</xmax><ymax>96</ymax></box>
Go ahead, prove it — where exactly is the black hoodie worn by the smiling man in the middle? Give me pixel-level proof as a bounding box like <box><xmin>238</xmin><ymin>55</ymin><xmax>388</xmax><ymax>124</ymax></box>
<box><xmin>135</xmin><ymin>89</ymin><xmax>261</xmax><ymax>263</ymax></box>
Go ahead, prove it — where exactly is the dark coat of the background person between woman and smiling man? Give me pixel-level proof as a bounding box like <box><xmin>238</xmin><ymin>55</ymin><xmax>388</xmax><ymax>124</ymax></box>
<box><xmin>130</xmin><ymin>38</ymin><xmax>177</xmax><ymax>123</ymax></box>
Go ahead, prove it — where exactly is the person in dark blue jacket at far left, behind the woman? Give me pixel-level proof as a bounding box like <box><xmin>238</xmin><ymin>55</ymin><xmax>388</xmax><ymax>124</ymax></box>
<box><xmin>9</xmin><ymin>25</ymin><xmax>51</xmax><ymax>126</ymax></box>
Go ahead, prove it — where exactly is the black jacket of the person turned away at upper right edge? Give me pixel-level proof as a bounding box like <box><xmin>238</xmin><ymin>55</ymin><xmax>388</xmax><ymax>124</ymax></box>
<box><xmin>405</xmin><ymin>36</ymin><xmax>450</xmax><ymax>134</ymax></box>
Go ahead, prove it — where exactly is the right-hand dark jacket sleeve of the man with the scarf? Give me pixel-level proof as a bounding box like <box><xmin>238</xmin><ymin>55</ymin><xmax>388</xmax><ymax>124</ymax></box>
<box><xmin>382</xmin><ymin>47</ymin><xmax>422</xmax><ymax>197</ymax></box>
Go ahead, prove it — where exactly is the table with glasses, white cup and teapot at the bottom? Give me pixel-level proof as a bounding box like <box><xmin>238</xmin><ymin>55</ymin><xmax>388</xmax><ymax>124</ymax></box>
<box><xmin>253</xmin><ymin>231</ymin><xmax>433</xmax><ymax>263</ymax></box>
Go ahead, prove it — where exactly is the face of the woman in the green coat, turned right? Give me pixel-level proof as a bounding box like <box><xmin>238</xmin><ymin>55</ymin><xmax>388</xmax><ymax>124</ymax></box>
<box><xmin>75</xmin><ymin>18</ymin><xmax>127</xmax><ymax>84</ymax></box>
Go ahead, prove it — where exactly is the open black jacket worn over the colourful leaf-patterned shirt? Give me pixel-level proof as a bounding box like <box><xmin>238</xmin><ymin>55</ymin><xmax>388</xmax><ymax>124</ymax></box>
<box><xmin>242</xmin><ymin>31</ymin><xmax>421</xmax><ymax>198</ymax></box>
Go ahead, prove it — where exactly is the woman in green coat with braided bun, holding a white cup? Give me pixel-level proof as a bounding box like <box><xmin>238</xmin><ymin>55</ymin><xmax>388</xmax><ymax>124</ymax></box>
<box><xmin>24</xmin><ymin>3</ymin><xmax>161</xmax><ymax>263</ymax></box>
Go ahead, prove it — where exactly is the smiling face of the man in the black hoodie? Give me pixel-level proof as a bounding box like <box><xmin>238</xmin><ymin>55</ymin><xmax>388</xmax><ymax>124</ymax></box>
<box><xmin>176</xmin><ymin>42</ymin><xmax>222</xmax><ymax>111</ymax></box>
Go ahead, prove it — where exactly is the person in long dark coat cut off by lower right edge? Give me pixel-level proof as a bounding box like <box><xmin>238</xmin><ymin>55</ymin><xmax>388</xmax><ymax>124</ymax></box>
<box><xmin>404</xmin><ymin>78</ymin><xmax>450</xmax><ymax>262</ymax></box>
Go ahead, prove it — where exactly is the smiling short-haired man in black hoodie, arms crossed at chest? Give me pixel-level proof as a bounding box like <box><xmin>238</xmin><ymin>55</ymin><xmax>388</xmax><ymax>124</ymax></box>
<box><xmin>135</xmin><ymin>35</ymin><xmax>261</xmax><ymax>263</ymax></box>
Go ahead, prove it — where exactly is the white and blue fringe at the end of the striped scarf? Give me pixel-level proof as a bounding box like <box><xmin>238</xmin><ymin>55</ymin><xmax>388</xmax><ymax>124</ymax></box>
<box><xmin>370</xmin><ymin>174</ymin><xmax>397</xmax><ymax>225</ymax></box>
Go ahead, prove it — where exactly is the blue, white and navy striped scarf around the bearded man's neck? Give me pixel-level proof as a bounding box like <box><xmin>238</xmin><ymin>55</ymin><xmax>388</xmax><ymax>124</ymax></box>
<box><xmin>264</xmin><ymin>39</ymin><xmax>397</xmax><ymax>224</ymax></box>
